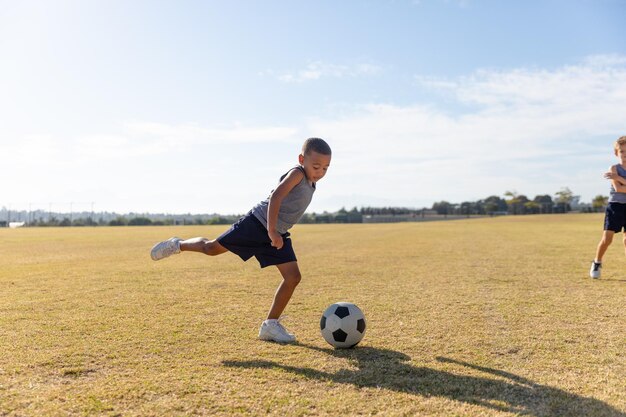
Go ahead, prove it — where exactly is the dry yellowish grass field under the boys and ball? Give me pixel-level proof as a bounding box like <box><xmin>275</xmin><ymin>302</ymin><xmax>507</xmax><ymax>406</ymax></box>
<box><xmin>0</xmin><ymin>214</ymin><xmax>626</xmax><ymax>416</ymax></box>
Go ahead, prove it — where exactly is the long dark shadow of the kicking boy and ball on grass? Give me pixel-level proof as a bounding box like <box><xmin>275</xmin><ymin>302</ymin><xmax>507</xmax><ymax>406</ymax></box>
<box><xmin>222</xmin><ymin>344</ymin><xmax>626</xmax><ymax>417</ymax></box>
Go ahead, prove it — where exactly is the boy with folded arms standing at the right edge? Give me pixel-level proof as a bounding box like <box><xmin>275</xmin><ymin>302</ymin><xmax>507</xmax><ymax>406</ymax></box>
<box><xmin>589</xmin><ymin>136</ymin><xmax>626</xmax><ymax>279</ymax></box>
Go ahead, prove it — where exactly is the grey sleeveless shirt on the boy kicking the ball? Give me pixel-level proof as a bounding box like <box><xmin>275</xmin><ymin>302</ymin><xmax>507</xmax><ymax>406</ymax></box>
<box><xmin>252</xmin><ymin>166</ymin><xmax>314</xmax><ymax>234</ymax></box>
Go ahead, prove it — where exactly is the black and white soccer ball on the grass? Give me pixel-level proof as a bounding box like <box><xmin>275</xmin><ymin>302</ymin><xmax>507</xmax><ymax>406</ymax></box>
<box><xmin>320</xmin><ymin>302</ymin><xmax>365</xmax><ymax>348</ymax></box>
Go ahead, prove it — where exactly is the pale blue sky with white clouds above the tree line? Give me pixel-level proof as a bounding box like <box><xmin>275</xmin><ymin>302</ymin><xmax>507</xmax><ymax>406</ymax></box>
<box><xmin>0</xmin><ymin>0</ymin><xmax>626</xmax><ymax>213</ymax></box>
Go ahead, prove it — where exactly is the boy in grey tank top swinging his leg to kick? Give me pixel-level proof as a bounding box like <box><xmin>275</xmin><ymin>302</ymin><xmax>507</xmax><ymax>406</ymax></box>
<box><xmin>150</xmin><ymin>138</ymin><xmax>331</xmax><ymax>343</ymax></box>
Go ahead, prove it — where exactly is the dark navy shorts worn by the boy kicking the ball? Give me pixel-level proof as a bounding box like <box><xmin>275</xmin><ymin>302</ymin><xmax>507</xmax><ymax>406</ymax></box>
<box><xmin>217</xmin><ymin>213</ymin><xmax>297</xmax><ymax>268</ymax></box>
